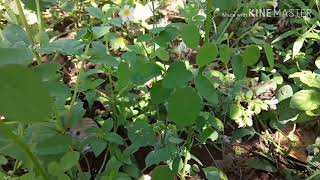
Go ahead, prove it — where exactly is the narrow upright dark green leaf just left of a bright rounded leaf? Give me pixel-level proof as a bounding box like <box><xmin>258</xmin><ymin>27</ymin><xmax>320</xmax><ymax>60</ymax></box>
<box><xmin>231</xmin><ymin>55</ymin><xmax>248</xmax><ymax>80</ymax></box>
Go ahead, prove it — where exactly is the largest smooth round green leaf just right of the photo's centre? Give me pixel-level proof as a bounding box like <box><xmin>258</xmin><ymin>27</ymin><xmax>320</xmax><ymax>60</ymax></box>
<box><xmin>168</xmin><ymin>87</ymin><xmax>202</xmax><ymax>127</ymax></box>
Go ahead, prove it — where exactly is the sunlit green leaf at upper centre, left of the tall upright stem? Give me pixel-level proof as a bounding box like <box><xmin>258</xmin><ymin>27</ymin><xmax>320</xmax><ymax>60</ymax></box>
<box><xmin>181</xmin><ymin>24</ymin><xmax>200</xmax><ymax>49</ymax></box>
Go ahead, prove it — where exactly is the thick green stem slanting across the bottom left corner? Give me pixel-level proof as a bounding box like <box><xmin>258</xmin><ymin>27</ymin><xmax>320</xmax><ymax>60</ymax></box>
<box><xmin>0</xmin><ymin>121</ymin><xmax>49</xmax><ymax>180</ymax></box>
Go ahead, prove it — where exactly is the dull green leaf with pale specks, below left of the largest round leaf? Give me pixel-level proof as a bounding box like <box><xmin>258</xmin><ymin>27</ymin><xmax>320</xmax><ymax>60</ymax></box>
<box><xmin>127</xmin><ymin>120</ymin><xmax>156</xmax><ymax>146</ymax></box>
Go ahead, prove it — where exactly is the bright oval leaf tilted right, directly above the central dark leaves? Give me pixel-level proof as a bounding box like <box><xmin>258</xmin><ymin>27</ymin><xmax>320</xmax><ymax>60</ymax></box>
<box><xmin>197</xmin><ymin>43</ymin><xmax>218</xmax><ymax>67</ymax></box>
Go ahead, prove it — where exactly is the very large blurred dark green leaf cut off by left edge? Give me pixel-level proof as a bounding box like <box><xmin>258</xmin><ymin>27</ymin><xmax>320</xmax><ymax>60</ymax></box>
<box><xmin>0</xmin><ymin>65</ymin><xmax>52</xmax><ymax>122</ymax></box>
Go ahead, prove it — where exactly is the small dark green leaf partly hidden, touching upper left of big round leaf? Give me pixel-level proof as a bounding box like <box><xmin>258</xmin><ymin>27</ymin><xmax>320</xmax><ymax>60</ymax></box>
<box><xmin>150</xmin><ymin>81</ymin><xmax>171</xmax><ymax>104</ymax></box>
